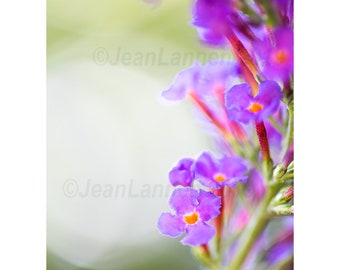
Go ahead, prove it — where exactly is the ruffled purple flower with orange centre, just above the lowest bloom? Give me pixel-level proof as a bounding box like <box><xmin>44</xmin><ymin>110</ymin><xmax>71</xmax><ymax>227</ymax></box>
<box><xmin>195</xmin><ymin>152</ymin><xmax>247</xmax><ymax>189</ymax></box>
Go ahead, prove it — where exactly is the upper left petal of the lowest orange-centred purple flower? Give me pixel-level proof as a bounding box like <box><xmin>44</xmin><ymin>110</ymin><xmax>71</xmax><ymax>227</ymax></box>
<box><xmin>169</xmin><ymin>187</ymin><xmax>198</xmax><ymax>215</ymax></box>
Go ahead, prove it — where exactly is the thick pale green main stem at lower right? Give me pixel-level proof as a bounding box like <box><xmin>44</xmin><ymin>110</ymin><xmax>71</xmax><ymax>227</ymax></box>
<box><xmin>228</xmin><ymin>182</ymin><xmax>281</xmax><ymax>270</ymax></box>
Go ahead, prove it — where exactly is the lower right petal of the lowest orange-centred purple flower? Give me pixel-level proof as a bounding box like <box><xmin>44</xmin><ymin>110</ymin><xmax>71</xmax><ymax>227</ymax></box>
<box><xmin>181</xmin><ymin>222</ymin><xmax>216</xmax><ymax>246</ymax></box>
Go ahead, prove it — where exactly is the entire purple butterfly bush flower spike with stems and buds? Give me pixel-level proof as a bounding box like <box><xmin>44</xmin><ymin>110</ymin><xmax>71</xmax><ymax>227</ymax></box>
<box><xmin>157</xmin><ymin>0</ymin><xmax>294</xmax><ymax>270</ymax></box>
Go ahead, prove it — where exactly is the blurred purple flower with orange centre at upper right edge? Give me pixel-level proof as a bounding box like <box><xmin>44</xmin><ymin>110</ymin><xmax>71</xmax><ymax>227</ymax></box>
<box><xmin>254</xmin><ymin>27</ymin><xmax>294</xmax><ymax>82</ymax></box>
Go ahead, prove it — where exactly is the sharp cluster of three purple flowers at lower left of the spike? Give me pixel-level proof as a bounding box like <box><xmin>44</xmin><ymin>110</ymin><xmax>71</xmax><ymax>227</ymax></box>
<box><xmin>158</xmin><ymin>152</ymin><xmax>247</xmax><ymax>246</ymax></box>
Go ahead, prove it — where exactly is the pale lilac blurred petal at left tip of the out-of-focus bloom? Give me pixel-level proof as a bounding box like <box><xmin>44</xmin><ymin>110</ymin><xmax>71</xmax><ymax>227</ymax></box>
<box><xmin>162</xmin><ymin>62</ymin><xmax>202</xmax><ymax>101</ymax></box>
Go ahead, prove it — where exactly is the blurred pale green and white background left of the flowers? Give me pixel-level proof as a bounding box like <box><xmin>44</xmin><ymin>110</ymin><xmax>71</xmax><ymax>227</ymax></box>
<box><xmin>47</xmin><ymin>0</ymin><xmax>229</xmax><ymax>270</ymax></box>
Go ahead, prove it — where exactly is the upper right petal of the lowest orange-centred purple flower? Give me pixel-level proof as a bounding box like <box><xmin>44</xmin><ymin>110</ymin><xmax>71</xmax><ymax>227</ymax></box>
<box><xmin>196</xmin><ymin>190</ymin><xmax>221</xmax><ymax>221</ymax></box>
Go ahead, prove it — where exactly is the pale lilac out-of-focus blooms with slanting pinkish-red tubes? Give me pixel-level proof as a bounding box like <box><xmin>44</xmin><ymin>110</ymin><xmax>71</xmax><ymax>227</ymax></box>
<box><xmin>162</xmin><ymin>60</ymin><xmax>245</xmax><ymax>141</ymax></box>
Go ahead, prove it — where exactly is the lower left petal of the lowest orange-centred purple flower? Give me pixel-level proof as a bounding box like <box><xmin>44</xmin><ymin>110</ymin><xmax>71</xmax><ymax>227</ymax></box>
<box><xmin>158</xmin><ymin>213</ymin><xmax>186</xmax><ymax>237</ymax></box>
